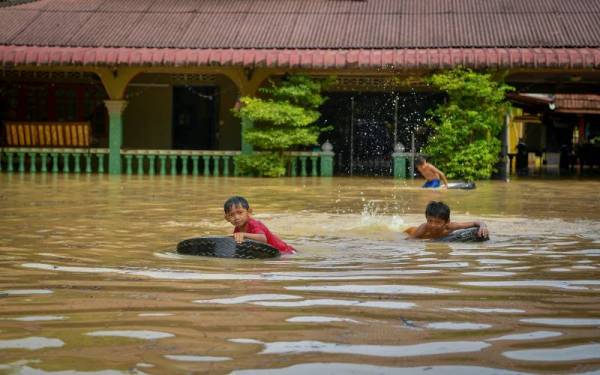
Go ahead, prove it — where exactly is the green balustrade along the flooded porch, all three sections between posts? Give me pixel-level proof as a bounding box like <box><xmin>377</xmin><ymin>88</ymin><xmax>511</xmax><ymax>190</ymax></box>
<box><xmin>0</xmin><ymin>147</ymin><xmax>333</xmax><ymax>177</ymax></box>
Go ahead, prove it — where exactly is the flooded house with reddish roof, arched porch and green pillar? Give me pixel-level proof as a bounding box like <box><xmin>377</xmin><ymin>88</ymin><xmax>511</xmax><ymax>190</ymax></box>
<box><xmin>0</xmin><ymin>0</ymin><xmax>600</xmax><ymax>175</ymax></box>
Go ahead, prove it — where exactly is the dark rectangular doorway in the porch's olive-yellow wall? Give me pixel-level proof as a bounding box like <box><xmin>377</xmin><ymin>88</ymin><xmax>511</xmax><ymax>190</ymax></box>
<box><xmin>173</xmin><ymin>86</ymin><xmax>219</xmax><ymax>150</ymax></box>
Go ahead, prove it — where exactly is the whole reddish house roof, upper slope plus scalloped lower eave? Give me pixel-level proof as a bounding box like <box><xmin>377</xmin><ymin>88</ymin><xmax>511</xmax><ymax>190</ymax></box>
<box><xmin>0</xmin><ymin>0</ymin><xmax>600</xmax><ymax>68</ymax></box>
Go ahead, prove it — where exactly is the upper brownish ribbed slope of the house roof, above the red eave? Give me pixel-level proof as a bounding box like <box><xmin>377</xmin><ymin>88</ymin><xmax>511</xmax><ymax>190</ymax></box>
<box><xmin>0</xmin><ymin>0</ymin><xmax>600</xmax><ymax>49</ymax></box>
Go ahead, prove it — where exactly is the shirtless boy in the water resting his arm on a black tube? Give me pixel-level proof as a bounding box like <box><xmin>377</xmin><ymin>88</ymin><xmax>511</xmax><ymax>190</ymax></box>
<box><xmin>404</xmin><ymin>201</ymin><xmax>489</xmax><ymax>239</ymax></box>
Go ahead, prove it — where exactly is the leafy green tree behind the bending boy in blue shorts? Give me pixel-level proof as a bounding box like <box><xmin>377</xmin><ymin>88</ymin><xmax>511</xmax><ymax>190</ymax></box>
<box><xmin>423</xmin><ymin>68</ymin><xmax>514</xmax><ymax>181</ymax></box>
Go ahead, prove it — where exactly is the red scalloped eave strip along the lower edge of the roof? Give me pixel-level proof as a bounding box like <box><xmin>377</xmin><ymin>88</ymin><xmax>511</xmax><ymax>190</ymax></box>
<box><xmin>0</xmin><ymin>46</ymin><xmax>600</xmax><ymax>69</ymax></box>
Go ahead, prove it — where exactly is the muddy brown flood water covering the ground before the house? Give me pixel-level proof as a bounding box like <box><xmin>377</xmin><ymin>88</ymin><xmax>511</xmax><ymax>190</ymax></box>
<box><xmin>0</xmin><ymin>174</ymin><xmax>600</xmax><ymax>374</ymax></box>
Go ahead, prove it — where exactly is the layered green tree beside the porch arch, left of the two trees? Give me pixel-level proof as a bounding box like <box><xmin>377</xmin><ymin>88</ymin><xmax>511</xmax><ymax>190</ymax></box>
<box><xmin>236</xmin><ymin>75</ymin><xmax>326</xmax><ymax>177</ymax></box>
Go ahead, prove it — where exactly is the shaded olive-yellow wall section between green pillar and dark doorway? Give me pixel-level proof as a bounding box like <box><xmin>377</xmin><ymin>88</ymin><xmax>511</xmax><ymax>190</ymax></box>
<box><xmin>123</xmin><ymin>85</ymin><xmax>173</xmax><ymax>149</ymax></box>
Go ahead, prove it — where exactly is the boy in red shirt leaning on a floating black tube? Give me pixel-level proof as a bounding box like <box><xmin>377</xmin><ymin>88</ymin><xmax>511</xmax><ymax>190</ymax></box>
<box><xmin>223</xmin><ymin>196</ymin><xmax>296</xmax><ymax>254</ymax></box>
